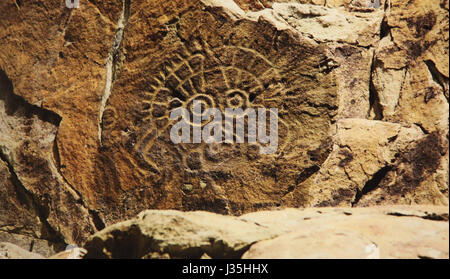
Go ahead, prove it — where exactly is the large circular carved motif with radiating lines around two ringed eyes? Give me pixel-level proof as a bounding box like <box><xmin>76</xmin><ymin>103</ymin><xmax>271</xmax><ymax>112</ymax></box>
<box><xmin>103</xmin><ymin>42</ymin><xmax>329</xmax><ymax>211</ymax></box>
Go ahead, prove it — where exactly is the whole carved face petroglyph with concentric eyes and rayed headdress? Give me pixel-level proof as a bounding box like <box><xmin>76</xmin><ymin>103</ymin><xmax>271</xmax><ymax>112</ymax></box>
<box><xmin>102</xmin><ymin>35</ymin><xmax>334</xmax><ymax>213</ymax></box>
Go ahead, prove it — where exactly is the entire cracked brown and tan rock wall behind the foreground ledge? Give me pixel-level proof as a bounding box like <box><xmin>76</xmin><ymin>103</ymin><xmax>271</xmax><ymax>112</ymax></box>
<box><xmin>0</xmin><ymin>0</ymin><xmax>449</xmax><ymax>249</ymax></box>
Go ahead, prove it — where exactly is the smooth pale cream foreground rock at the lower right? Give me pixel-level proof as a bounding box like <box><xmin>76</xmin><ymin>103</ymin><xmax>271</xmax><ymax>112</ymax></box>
<box><xmin>241</xmin><ymin>206</ymin><xmax>449</xmax><ymax>259</ymax></box>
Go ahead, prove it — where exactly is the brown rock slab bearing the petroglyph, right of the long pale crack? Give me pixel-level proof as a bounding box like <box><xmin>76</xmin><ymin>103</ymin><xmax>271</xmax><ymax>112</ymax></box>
<box><xmin>96</xmin><ymin>1</ymin><xmax>337</xmax><ymax>220</ymax></box>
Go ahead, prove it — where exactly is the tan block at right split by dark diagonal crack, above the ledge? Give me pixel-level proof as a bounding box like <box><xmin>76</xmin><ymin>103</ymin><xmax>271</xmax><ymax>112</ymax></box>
<box><xmin>304</xmin><ymin>119</ymin><xmax>448</xmax><ymax>206</ymax></box>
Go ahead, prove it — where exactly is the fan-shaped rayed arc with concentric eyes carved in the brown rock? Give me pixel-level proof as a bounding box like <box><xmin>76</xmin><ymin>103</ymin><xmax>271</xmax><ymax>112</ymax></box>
<box><xmin>128</xmin><ymin>46</ymin><xmax>289</xmax><ymax>173</ymax></box>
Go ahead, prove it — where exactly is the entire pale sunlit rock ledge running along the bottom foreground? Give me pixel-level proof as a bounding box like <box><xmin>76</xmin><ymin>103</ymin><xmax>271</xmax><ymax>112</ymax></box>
<box><xmin>86</xmin><ymin>206</ymin><xmax>449</xmax><ymax>259</ymax></box>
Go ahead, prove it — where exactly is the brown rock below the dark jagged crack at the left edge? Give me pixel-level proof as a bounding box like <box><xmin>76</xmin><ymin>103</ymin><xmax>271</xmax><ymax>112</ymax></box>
<box><xmin>0</xmin><ymin>68</ymin><xmax>93</xmax><ymax>249</ymax></box>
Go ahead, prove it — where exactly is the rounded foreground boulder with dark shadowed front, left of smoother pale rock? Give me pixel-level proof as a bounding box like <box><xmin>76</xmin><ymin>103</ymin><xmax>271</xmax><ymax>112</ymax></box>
<box><xmin>85</xmin><ymin>210</ymin><xmax>277</xmax><ymax>258</ymax></box>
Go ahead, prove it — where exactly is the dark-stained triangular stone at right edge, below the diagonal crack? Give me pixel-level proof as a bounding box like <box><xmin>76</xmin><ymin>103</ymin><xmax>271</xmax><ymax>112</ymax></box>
<box><xmin>358</xmin><ymin>133</ymin><xmax>448</xmax><ymax>206</ymax></box>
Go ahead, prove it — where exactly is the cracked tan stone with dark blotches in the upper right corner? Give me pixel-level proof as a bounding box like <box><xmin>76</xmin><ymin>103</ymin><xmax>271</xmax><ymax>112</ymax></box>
<box><xmin>372</xmin><ymin>1</ymin><xmax>449</xmax><ymax>132</ymax></box>
